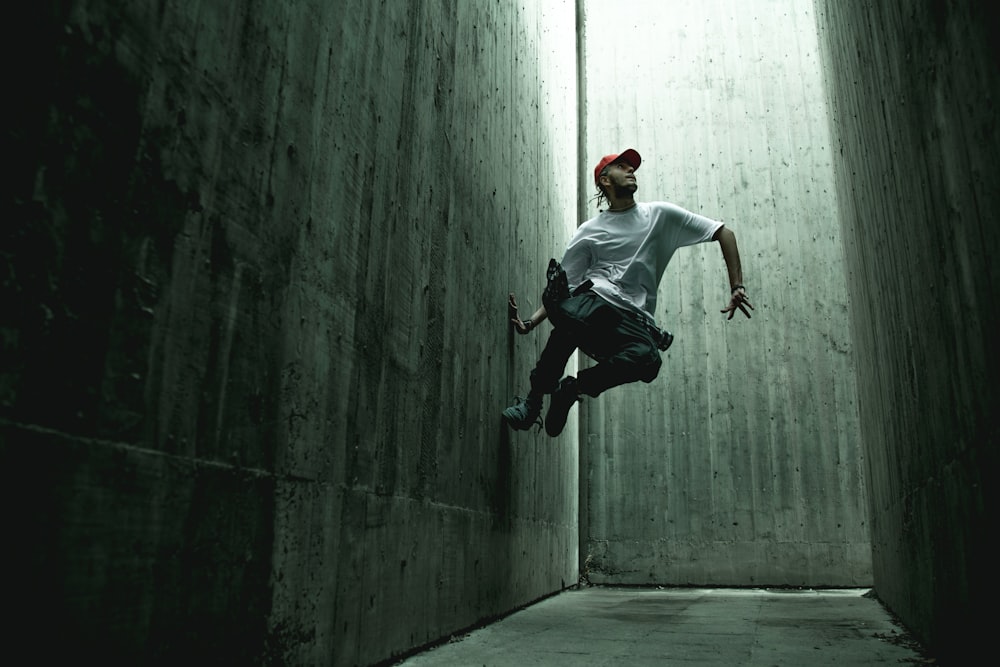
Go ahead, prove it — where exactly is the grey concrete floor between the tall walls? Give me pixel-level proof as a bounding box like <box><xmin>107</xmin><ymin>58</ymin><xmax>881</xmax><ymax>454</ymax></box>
<box><xmin>396</xmin><ymin>587</ymin><xmax>930</xmax><ymax>667</ymax></box>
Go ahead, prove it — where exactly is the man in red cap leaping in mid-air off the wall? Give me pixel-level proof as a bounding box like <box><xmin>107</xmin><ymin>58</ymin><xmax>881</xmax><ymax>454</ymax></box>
<box><xmin>503</xmin><ymin>148</ymin><xmax>753</xmax><ymax>437</ymax></box>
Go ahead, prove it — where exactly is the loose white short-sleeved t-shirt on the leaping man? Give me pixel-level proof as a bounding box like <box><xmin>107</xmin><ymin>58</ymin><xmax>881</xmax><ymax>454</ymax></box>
<box><xmin>562</xmin><ymin>202</ymin><xmax>722</xmax><ymax>321</ymax></box>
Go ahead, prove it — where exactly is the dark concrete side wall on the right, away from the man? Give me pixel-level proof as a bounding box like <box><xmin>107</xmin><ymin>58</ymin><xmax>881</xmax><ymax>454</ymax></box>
<box><xmin>817</xmin><ymin>0</ymin><xmax>1000</xmax><ymax>665</ymax></box>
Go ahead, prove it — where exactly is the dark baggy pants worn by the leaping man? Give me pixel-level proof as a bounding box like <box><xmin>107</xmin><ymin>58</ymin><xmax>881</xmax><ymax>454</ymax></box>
<box><xmin>531</xmin><ymin>292</ymin><xmax>663</xmax><ymax>396</ymax></box>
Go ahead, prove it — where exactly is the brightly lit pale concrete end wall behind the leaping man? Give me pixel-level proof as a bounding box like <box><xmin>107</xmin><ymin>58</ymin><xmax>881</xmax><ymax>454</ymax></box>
<box><xmin>581</xmin><ymin>0</ymin><xmax>871</xmax><ymax>586</ymax></box>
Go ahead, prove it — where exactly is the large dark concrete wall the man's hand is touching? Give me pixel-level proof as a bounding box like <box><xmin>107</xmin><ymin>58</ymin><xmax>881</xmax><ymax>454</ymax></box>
<box><xmin>0</xmin><ymin>0</ymin><xmax>578</xmax><ymax>665</ymax></box>
